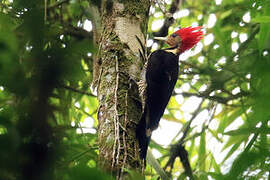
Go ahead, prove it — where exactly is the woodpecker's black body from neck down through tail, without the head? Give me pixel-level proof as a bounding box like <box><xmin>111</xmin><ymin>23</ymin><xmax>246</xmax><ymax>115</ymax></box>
<box><xmin>137</xmin><ymin>50</ymin><xmax>179</xmax><ymax>159</ymax></box>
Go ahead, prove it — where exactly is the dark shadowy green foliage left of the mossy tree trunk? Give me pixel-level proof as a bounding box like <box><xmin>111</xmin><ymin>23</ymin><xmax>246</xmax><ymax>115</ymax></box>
<box><xmin>0</xmin><ymin>1</ymin><xmax>100</xmax><ymax>179</ymax></box>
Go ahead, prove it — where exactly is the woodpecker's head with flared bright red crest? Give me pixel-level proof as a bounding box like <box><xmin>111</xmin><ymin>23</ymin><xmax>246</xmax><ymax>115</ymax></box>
<box><xmin>167</xmin><ymin>26</ymin><xmax>203</xmax><ymax>53</ymax></box>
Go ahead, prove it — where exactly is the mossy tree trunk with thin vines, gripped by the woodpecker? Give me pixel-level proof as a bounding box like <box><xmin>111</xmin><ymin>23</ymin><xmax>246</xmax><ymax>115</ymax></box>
<box><xmin>97</xmin><ymin>0</ymin><xmax>150</xmax><ymax>179</ymax></box>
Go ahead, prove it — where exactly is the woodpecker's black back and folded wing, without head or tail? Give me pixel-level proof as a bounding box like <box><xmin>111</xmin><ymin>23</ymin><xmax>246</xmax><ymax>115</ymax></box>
<box><xmin>145</xmin><ymin>50</ymin><xmax>179</xmax><ymax>131</ymax></box>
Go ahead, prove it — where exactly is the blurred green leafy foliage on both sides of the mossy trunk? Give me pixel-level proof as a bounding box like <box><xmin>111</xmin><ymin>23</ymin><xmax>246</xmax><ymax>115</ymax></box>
<box><xmin>0</xmin><ymin>0</ymin><xmax>270</xmax><ymax>180</ymax></box>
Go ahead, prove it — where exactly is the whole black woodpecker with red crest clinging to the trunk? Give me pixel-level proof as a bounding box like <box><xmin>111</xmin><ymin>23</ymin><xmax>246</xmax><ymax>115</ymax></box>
<box><xmin>136</xmin><ymin>26</ymin><xmax>203</xmax><ymax>160</ymax></box>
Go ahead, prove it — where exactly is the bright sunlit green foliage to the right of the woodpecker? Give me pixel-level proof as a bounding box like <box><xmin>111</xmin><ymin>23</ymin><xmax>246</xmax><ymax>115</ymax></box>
<box><xmin>149</xmin><ymin>0</ymin><xmax>270</xmax><ymax>179</ymax></box>
